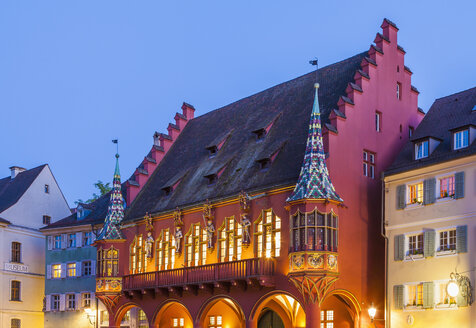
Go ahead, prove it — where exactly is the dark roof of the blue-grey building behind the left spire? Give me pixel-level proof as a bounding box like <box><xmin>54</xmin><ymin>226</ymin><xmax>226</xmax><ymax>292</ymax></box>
<box><xmin>40</xmin><ymin>183</ymin><xmax>127</xmax><ymax>231</ymax></box>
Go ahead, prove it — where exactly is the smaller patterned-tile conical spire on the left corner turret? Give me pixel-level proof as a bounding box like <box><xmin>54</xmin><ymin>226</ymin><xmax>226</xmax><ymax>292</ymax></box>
<box><xmin>97</xmin><ymin>154</ymin><xmax>125</xmax><ymax>240</ymax></box>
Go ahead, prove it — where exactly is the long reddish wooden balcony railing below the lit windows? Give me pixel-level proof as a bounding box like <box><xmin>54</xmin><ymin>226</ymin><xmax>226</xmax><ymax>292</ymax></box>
<box><xmin>123</xmin><ymin>258</ymin><xmax>275</xmax><ymax>290</ymax></box>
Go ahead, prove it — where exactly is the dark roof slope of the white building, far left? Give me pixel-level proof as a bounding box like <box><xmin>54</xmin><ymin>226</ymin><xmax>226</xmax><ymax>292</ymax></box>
<box><xmin>0</xmin><ymin>164</ymin><xmax>47</xmax><ymax>213</ymax></box>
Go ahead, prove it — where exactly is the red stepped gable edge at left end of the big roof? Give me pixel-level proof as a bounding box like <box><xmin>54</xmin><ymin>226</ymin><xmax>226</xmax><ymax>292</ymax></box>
<box><xmin>126</xmin><ymin>102</ymin><xmax>195</xmax><ymax>204</ymax></box>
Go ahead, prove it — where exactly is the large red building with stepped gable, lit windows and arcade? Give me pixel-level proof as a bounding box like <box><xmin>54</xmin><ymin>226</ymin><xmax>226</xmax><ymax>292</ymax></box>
<box><xmin>96</xmin><ymin>20</ymin><xmax>423</xmax><ymax>328</ymax></box>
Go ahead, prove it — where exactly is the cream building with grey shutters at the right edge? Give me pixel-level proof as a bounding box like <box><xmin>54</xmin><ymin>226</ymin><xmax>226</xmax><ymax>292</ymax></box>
<box><xmin>385</xmin><ymin>88</ymin><xmax>476</xmax><ymax>328</ymax></box>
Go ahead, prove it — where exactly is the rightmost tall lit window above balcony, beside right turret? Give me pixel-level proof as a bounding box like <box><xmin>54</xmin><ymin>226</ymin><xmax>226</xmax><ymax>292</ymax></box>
<box><xmin>254</xmin><ymin>210</ymin><xmax>281</xmax><ymax>257</ymax></box>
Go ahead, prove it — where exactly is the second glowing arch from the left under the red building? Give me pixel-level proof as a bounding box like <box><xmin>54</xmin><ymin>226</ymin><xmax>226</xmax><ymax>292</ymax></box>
<box><xmin>152</xmin><ymin>298</ymin><xmax>193</xmax><ymax>328</ymax></box>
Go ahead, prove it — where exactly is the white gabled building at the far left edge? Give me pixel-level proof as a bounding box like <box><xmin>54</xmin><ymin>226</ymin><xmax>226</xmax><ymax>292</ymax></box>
<box><xmin>0</xmin><ymin>164</ymin><xmax>71</xmax><ymax>328</ymax></box>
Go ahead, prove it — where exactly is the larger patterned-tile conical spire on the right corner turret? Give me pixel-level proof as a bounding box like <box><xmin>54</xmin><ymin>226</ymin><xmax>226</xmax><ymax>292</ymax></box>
<box><xmin>287</xmin><ymin>83</ymin><xmax>343</xmax><ymax>202</ymax></box>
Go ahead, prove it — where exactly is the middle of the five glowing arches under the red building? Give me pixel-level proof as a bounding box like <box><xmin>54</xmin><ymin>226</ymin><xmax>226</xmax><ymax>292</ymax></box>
<box><xmin>195</xmin><ymin>295</ymin><xmax>246</xmax><ymax>328</ymax></box>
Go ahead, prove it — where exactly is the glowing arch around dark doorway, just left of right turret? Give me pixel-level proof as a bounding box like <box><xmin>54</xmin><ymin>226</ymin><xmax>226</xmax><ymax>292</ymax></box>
<box><xmin>249</xmin><ymin>290</ymin><xmax>306</xmax><ymax>327</ymax></box>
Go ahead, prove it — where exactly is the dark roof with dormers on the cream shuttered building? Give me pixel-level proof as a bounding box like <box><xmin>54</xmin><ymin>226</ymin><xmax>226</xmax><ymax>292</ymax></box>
<box><xmin>385</xmin><ymin>87</ymin><xmax>476</xmax><ymax>176</ymax></box>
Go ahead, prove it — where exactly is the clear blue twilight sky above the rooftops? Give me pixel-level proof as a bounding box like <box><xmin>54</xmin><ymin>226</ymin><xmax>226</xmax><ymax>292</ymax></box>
<box><xmin>0</xmin><ymin>0</ymin><xmax>476</xmax><ymax>205</ymax></box>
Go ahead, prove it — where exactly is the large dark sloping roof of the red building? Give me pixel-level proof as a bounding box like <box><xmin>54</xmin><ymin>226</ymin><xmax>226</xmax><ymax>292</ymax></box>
<box><xmin>125</xmin><ymin>52</ymin><xmax>368</xmax><ymax>221</ymax></box>
